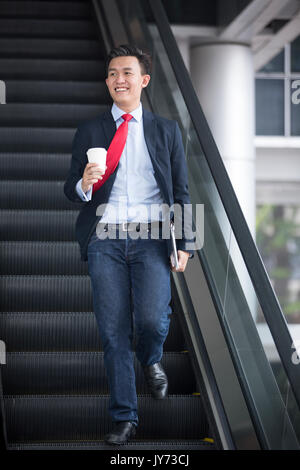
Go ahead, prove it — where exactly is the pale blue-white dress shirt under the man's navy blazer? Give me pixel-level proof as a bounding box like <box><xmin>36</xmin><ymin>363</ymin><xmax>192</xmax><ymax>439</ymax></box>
<box><xmin>76</xmin><ymin>103</ymin><xmax>164</xmax><ymax>223</ymax></box>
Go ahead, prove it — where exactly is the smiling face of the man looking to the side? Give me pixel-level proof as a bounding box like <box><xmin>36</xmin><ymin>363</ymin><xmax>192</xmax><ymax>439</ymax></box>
<box><xmin>106</xmin><ymin>56</ymin><xmax>150</xmax><ymax>112</ymax></box>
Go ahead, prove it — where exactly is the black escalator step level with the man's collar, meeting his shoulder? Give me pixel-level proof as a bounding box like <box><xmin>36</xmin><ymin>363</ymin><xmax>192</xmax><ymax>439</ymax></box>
<box><xmin>0</xmin><ymin>103</ymin><xmax>107</xmax><ymax>127</ymax></box>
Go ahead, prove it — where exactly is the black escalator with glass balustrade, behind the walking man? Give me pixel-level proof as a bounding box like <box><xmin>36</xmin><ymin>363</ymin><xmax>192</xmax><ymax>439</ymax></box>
<box><xmin>0</xmin><ymin>0</ymin><xmax>300</xmax><ymax>450</ymax></box>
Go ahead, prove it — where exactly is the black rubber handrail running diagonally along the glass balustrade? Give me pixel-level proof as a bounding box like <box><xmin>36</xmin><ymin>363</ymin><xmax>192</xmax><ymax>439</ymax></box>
<box><xmin>148</xmin><ymin>0</ymin><xmax>300</xmax><ymax>408</ymax></box>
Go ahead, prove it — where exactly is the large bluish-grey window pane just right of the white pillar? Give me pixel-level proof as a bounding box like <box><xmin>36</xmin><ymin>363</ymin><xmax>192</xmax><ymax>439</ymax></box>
<box><xmin>255</xmin><ymin>78</ymin><xmax>284</xmax><ymax>135</ymax></box>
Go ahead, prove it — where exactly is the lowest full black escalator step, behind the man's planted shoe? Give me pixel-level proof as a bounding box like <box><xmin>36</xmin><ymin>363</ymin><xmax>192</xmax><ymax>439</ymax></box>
<box><xmin>4</xmin><ymin>395</ymin><xmax>208</xmax><ymax>443</ymax></box>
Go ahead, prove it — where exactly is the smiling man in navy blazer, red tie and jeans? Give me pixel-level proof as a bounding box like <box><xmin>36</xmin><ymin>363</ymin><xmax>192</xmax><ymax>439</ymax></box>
<box><xmin>64</xmin><ymin>45</ymin><xmax>192</xmax><ymax>444</ymax></box>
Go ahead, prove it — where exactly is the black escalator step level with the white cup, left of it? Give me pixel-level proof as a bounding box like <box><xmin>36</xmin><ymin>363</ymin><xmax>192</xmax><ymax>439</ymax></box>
<box><xmin>0</xmin><ymin>153</ymin><xmax>71</xmax><ymax>182</ymax></box>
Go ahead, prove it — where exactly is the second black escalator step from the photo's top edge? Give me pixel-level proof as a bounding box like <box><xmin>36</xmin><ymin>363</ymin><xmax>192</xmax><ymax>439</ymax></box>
<box><xmin>0</xmin><ymin>18</ymin><xmax>98</xmax><ymax>39</ymax></box>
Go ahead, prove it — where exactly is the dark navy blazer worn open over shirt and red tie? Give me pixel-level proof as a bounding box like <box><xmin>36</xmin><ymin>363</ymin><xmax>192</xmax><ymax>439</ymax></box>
<box><xmin>64</xmin><ymin>109</ymin><xmax>192</xmax><ymax>261</ymax></box>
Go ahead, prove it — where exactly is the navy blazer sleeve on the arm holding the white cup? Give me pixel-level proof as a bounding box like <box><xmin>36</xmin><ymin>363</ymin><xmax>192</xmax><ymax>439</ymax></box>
<box><xmin>64</xmin><ymin>126</ymin><xmax>89</xmax><ymax>204</ymax></box>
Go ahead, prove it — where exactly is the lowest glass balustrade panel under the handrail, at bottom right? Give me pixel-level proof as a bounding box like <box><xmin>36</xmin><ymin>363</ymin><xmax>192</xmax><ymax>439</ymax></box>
<box><xmin>224</xmin><ymin>229</ymin><xmax>300</xmax><ymax>450</ymax></box>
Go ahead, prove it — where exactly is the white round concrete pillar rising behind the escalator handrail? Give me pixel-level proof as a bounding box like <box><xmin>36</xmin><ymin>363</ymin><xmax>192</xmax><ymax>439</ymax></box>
<box><xmin>190</xmin><ymin>42</ymin><xmax>255</xmax><ymax>237</ymax></box>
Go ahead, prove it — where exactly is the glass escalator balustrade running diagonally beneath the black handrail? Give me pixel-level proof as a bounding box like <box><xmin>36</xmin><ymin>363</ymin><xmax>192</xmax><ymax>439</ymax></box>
<box><xmin>95</xmin><ymin>0</ymin><xmax>300</xmax><ymax>449</ymax></box>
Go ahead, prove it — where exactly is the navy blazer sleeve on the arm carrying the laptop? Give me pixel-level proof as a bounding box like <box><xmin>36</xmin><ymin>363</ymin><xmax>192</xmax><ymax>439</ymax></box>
<box><xmin>171</xmin><ymin>121</ymin><xmax>195</xmax><ymax>257</ymax></box>
